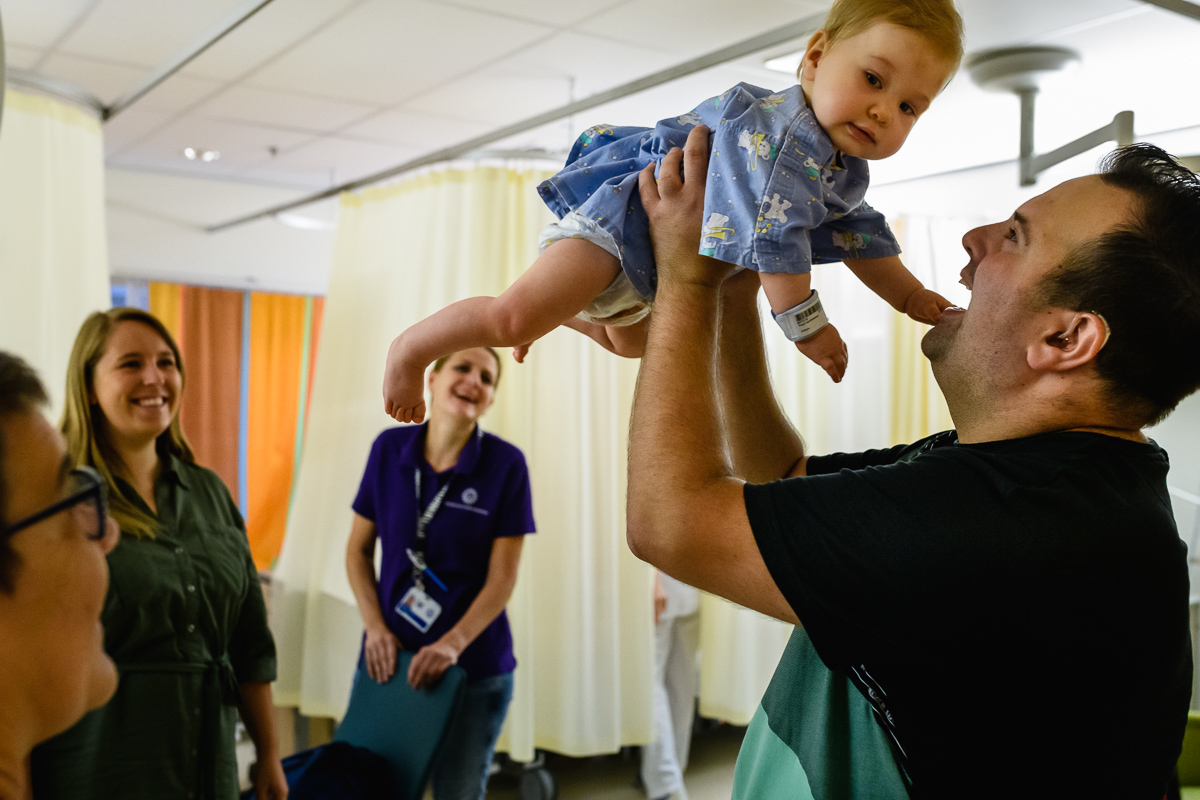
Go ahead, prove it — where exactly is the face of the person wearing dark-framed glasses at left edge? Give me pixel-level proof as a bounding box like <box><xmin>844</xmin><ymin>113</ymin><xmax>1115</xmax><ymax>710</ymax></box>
<box><xmin>0</xmin><ymin>410</ymin><xmax>119</xmax><ymax>738</ymax></box>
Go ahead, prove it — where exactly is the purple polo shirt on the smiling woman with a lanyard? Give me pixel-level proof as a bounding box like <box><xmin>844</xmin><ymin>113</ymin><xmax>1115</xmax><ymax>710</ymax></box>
<box><xmin>354</xmin><ymin>425</ymin><xmax>534</xmax><ymax>680</ymax></box>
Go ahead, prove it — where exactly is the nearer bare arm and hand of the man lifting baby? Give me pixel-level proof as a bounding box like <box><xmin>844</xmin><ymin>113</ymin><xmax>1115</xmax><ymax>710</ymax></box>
<box><xmin>628</xmin><ymin>127</ymin><xmax>799</xmax><ymax>624</ymax></box>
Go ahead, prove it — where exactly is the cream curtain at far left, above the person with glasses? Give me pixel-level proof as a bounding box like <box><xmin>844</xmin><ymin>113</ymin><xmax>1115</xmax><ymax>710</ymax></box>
<box><xmin>0</xmin><ymin>88</ymin><xmax>112</xmax><ymax>410</ymax></box>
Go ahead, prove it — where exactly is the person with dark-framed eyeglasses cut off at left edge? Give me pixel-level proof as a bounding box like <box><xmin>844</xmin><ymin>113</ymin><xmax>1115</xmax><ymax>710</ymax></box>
<box><xmin>0</xmin><ymin>353</ymin><xmax>118</xmax><ymax>799</ymax></box>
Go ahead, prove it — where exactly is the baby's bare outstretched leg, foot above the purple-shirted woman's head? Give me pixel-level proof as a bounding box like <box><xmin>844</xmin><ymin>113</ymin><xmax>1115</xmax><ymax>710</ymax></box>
<box><xmin>383</xmin><ymin>239</ymin><xmax>620</xmax><ymax>422</ymax></box>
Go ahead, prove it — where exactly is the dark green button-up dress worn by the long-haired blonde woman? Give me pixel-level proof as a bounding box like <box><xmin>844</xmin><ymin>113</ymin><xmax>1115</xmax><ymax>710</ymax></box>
<box><xmin>32</xmin><ymin>457</ymin><xmax>275</xmax><ymax>800</ymax></box>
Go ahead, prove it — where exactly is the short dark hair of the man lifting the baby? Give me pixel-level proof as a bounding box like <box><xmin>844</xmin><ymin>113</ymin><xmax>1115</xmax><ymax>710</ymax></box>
<box><xmin>1040</xmin><ymin>144</ymin><xmax>1200</xmax><ymax>425</ymax></box>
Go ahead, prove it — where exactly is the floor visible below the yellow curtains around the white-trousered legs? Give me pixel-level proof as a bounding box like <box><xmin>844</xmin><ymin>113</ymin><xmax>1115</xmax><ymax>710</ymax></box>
<box><xmin>487</xmin><ymin>723</ymin><xmax>745</xmax><ymax>800</ymax></box>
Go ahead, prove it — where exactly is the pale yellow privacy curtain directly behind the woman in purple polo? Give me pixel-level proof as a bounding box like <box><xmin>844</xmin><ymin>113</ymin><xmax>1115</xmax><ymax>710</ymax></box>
<box><xmin>271</xmin><ymin>167</ymin><xmax>653</xmax><ymax>759</ymax></box>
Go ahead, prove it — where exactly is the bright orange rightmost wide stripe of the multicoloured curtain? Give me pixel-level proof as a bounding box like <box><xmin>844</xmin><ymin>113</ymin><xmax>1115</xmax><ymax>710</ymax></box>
<box><xmin>246</xmin><ymin>293</ymin><xmax>305</xmax><ymax>570</ymax></box>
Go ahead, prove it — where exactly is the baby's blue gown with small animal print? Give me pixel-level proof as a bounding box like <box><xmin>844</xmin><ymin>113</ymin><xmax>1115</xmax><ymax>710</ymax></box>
<box><xmin>538</xmin><ymin>83</ymin><xmax>900</xmax><ymax>321</ymax></box>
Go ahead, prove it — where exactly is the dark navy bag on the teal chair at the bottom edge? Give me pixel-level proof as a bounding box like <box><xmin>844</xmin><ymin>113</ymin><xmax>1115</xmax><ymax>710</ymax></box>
<box><xmin>241</xmin><ymin>741</ymin><xmax>396</xmax><ymax>800</ymax></box>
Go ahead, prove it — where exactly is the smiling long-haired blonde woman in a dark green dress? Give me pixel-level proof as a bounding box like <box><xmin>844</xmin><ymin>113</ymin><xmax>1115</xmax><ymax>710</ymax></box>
<box><xmin>32</xmin><ymin>308</ymin><xmax>287</xmax><ymax>800</ymax></box>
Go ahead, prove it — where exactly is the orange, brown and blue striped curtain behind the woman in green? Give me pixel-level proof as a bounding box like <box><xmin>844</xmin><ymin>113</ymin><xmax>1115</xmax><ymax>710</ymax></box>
<box><xmin>127</xmin><ymin>283</ymin><xmax>324</xmax><ymax>570</ymax></box>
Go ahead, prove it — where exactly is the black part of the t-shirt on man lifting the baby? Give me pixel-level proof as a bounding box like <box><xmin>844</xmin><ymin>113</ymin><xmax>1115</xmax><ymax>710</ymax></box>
<box><xmin>745</xmin><ymin>432</ymin><xmax>1192</xmax><ymax>798</ymax></box>
